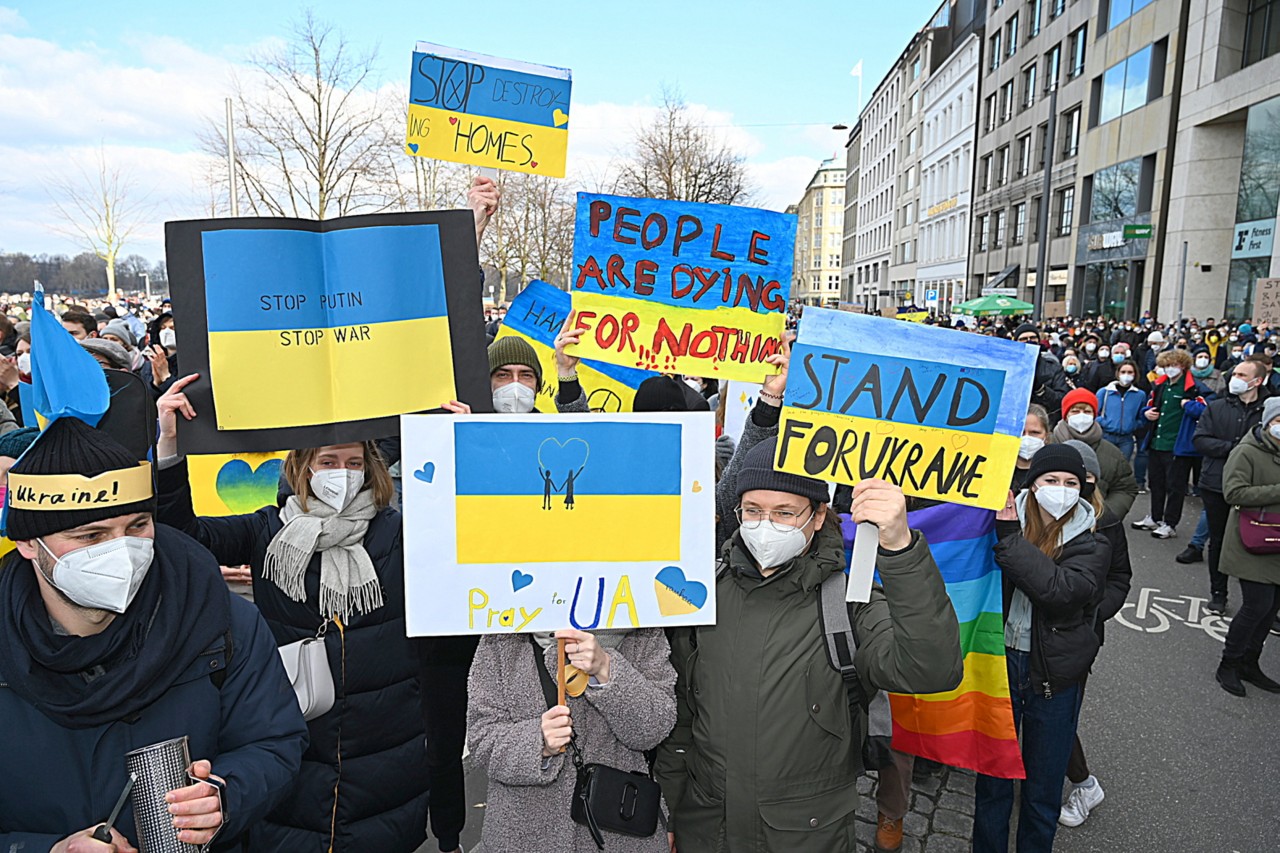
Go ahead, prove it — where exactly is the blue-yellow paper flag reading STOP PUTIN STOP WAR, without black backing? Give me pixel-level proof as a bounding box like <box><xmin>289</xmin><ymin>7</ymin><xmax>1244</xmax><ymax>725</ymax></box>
<box><xmin>200</xmin><ymin>224</ymin><xmax>457</xmax><ymax>429</ymax></box>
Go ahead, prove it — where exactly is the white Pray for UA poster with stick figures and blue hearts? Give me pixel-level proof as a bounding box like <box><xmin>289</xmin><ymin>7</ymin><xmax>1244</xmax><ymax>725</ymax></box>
<box><xmin>401</xmin><ymin>412</ymin><xmax>716</xmax><ymax>637</ymax></box>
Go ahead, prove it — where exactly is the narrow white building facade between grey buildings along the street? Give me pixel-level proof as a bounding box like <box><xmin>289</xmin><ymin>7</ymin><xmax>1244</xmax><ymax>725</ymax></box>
<box><xmin>915</xmin><ymin>33</ymin><xmax>982</xmax><ymax>313</ymax></box>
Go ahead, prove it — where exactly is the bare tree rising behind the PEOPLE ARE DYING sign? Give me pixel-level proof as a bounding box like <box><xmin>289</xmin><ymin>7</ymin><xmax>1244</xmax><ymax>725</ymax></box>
<box><xmin>618</xmin><ymin>90</ymin><xmax>755</xmax><ymax>205</ymax></box>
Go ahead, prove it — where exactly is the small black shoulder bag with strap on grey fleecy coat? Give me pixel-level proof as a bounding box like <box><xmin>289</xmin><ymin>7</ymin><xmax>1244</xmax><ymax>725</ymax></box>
<box><xmin>529</xmin><ymin>634</ymin><xmax>662</xmax><ymax>850</ymax></box>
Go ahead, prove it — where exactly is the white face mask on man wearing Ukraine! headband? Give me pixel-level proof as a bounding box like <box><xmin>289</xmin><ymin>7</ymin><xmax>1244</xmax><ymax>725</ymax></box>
<box><xmin>33</xmin><ymin>537</ymin><xmax>155</xmax><ymax>613</ymax></box>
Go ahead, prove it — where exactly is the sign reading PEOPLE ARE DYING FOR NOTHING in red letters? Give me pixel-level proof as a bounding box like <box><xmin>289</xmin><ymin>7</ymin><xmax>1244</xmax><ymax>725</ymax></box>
<box><xmin>571</xmin><ymin>193</ymin><xmax>796</xmax><ymax>382</ymax></box>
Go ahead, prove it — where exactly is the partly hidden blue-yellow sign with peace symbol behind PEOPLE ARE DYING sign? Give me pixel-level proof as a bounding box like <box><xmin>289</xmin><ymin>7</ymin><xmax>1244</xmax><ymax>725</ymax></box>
<box><xmin>497</xmin><ymin>282</ymin><xmax>658</xmax><ymax>415</ymax></box>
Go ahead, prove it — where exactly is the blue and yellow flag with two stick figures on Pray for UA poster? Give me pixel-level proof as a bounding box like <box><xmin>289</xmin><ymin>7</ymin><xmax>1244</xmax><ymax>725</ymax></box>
<box><xmin>453</xmin><ymin>418</ymin><xmax>682</xmax><ymax>564</ymax></box>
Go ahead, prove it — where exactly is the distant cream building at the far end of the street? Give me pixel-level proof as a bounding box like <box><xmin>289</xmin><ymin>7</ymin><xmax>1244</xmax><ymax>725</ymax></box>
<box><xmin>791</xmin><ymin>158</ymin><xmax>845</xmax><ymax>307</ymax></box>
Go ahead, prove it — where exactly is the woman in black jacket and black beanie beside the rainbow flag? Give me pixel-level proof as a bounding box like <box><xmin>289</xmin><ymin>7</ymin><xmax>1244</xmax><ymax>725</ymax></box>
<box><xmin>973</xmin><ymin>444</ymin><xmax>1111</xmax><ymax>853</ymax></box>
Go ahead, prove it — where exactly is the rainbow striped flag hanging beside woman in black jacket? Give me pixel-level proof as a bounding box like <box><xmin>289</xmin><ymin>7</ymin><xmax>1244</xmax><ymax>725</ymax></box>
<box><xmin>842</xmin><ymin>503</ymin><xmax>1027</xmax><ymax>779</ymax></box>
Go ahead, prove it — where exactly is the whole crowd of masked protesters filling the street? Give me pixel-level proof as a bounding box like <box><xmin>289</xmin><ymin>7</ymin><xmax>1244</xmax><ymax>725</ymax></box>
<box><xmin>0</xmin><ymin>178</ymin><xmax>1280</xmax><ymax>853</ymax></box>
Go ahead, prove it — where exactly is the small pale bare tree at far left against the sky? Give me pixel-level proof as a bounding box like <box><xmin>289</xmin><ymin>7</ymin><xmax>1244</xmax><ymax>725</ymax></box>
<box><xmin>49</xmin><ymin>147</ymin><xmax>145</xmax><ymax>302</ymax></box>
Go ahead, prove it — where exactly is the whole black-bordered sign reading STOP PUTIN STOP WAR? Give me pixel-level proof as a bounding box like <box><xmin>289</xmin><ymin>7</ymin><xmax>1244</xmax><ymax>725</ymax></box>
<box><xmin>165</xmin><ymin>210</ymin><xmax>492</xmax><ymax>453</ymax></box>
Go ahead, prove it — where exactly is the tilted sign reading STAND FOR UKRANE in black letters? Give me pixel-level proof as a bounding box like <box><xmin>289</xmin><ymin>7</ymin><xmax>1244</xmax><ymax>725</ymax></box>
<box><xmin>774</xmin><ymin>307</ymin><xmax>1036</xmax><ymax>510</ymax></box>
